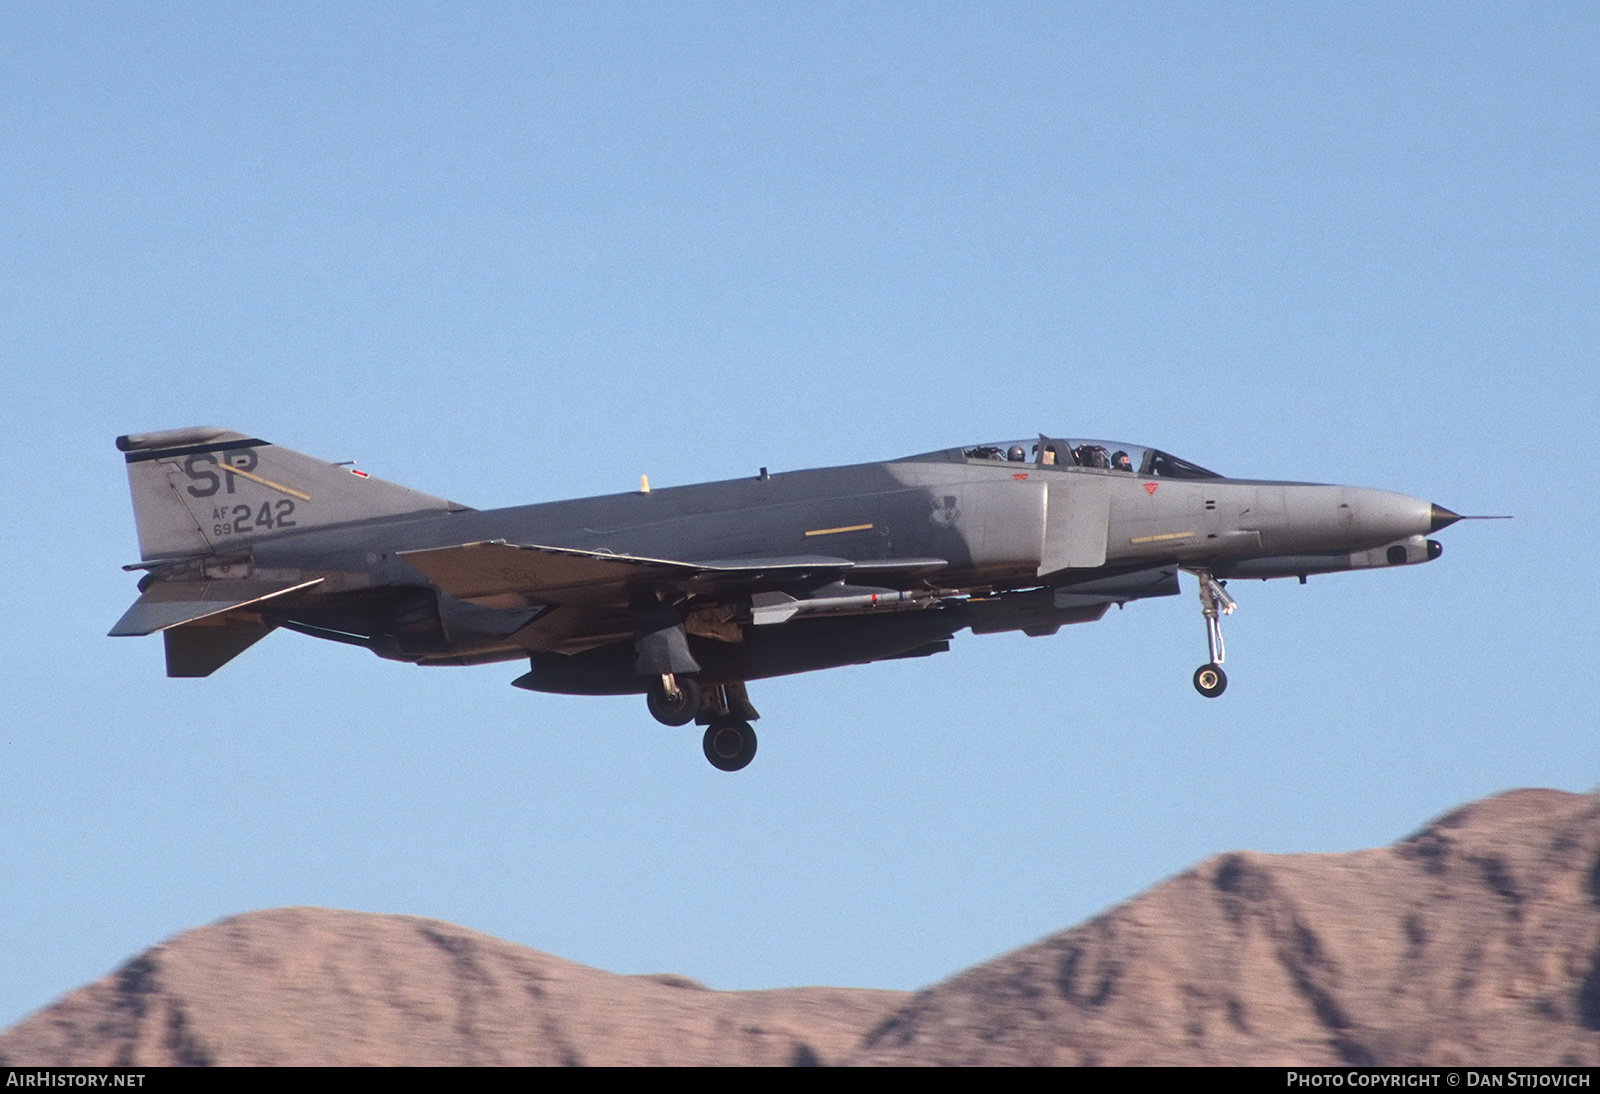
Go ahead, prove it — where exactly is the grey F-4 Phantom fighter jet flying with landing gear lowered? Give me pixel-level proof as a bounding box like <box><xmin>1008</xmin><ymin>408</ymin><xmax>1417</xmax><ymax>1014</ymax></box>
<box><xmin>110</xmin><ymin>427</ymin><xmax>1461</xmax><ymax>771</ymax></box>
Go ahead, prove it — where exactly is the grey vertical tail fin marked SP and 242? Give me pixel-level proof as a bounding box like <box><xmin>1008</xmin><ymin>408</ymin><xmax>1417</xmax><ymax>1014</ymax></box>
<box><xmin>117</xmin><ymin>425</ymin><xmax>466</xmax><ymax>561</ymax></box>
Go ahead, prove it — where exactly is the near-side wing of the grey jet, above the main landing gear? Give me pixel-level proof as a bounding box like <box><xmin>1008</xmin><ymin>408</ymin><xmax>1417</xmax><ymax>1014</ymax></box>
<box><xmin>402</xmin><ymin>539</ymin><xmax>947</xmax><ymax>605</ymax></box>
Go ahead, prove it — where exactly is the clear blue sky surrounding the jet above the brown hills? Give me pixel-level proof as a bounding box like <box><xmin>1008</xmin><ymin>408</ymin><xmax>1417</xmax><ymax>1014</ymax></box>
<box><xmin>0</xmin><ymin>3</ymin><xmax>1600</xmax><ymax>1024</ymax></box>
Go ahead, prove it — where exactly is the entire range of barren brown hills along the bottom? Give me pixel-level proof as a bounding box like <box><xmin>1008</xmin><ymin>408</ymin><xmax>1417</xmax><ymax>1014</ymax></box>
<box><xmin>0</xmin><ymin>790</ymin><xmax>1600</xmax><ymax>1065</ymax></box>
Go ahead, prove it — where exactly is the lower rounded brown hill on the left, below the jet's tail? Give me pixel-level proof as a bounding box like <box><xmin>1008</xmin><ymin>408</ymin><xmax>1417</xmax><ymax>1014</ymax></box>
<box><xmin>0</xmin><ymin>908</ymin><xmax>909</xmax><ymax>1065</ymax></box>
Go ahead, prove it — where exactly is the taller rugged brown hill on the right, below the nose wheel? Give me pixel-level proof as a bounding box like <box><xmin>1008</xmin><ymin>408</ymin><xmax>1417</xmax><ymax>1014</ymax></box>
<box><xmin>858</xmin><ymin>790</ymin><xmax>1600</xmax><ymax>1065</ymax></box>
